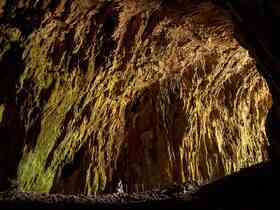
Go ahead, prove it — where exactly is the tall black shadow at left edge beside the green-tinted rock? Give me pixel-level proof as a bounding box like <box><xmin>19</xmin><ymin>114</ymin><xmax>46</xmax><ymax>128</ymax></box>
<box><xmin>0</xmin><ymin>42</ymin><xmax>24</xmax><ymax>191</ymax></box>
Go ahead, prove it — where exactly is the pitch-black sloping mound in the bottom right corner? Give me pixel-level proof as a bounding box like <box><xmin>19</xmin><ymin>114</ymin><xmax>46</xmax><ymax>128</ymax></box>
<box><xmin>192</xmin><ymin>160</ymin><xmax>280</xmax><ymax>210</ymax></box>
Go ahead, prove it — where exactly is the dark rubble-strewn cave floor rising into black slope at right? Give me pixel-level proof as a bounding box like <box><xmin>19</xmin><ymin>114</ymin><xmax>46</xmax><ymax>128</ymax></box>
<box><xmin>0</xmin><ymin>161</ymin><xmax>280</xmax><ymax>210</ymax></box>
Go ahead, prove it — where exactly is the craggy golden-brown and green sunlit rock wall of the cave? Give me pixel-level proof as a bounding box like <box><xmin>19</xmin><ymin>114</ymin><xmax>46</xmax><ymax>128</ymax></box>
<box><xmin>0</xmin><ymin>0</ymin><xmax>271</xmax><ymax>194</ymax></box>
